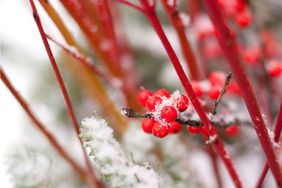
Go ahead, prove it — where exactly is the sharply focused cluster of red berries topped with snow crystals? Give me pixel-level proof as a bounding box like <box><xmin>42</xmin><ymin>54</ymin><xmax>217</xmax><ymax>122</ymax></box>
<box><xmin>137</xmin><ymin>89</ymin><xmax>189</xmax><ymax>138</ymax></box>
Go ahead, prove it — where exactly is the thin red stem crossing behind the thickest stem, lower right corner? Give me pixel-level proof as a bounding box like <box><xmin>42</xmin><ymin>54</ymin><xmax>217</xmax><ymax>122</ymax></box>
<box><xmin>256</xmin><ymin>100</ymin><xmax>282</xmax><ymax>188</ymax></box>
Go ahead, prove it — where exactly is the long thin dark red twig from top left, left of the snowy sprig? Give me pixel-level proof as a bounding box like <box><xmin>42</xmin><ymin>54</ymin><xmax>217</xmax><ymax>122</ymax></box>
<box><xmin>29</xmin><ymin>0</ymin><xmax>101</xmax><ymax>187</ymax></box>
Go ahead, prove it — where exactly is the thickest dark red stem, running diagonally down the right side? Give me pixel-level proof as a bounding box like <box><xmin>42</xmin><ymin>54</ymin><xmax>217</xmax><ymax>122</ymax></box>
<box><xmin>204</xmin><ymin>0</ymin><xmax>282</xmax><ymax>186</ymax></box>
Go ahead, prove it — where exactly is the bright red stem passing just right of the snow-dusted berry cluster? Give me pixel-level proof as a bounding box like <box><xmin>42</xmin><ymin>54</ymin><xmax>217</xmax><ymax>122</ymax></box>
<box><xmin>140</xmin><ymin>0</ymin><xmax>242</xmax><ymax>187</ymax></box>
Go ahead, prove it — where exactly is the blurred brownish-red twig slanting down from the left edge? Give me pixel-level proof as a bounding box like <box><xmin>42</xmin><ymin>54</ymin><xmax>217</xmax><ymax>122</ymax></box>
<box><xmin>0</xmin><ymin>67</ymin><xmax>87</xmax><ymax>179</ymax></box>
